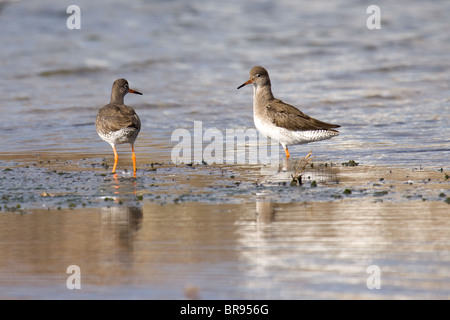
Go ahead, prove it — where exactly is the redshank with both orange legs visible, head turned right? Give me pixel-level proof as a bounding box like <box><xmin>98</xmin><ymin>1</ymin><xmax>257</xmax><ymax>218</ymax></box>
<box><xmin>95</xmin><ymin>79</ymin><xmax>142</xmax><ymax>175</ymax></box>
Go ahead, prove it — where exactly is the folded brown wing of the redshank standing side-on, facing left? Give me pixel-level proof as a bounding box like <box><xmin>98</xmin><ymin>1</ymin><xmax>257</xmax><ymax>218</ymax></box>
<box><xmin>266</xmin><ymin>99</ymin><xmax>340</xmax><ymax>131</ymax></box>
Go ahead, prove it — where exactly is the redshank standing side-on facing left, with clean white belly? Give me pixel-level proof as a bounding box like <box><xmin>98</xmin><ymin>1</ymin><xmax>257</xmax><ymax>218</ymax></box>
<box><xmin>238</xmin><ymin>66</ymin><xmax>340</xmax><ymax>159</ymax></box>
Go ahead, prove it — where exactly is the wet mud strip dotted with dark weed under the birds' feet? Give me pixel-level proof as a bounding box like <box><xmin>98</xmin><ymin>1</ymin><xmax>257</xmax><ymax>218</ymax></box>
<box><xmin>0</xmin><ymin>152</ymin><xmax>450</xmax><ymax>212</ymax></box>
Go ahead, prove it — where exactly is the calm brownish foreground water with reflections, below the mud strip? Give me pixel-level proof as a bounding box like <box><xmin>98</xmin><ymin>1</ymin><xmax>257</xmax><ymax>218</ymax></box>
<box><xmin>0</xmin><ymin>200</ymin><xmax>450</xmax><ymax>299</ymax></box>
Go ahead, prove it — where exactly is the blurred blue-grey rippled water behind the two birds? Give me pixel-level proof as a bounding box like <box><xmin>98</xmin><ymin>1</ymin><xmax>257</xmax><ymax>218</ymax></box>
<box><xmin>0</xmin><ymin>0</ymin><xmax>450</xmax><ymax>166</ymax></box>
